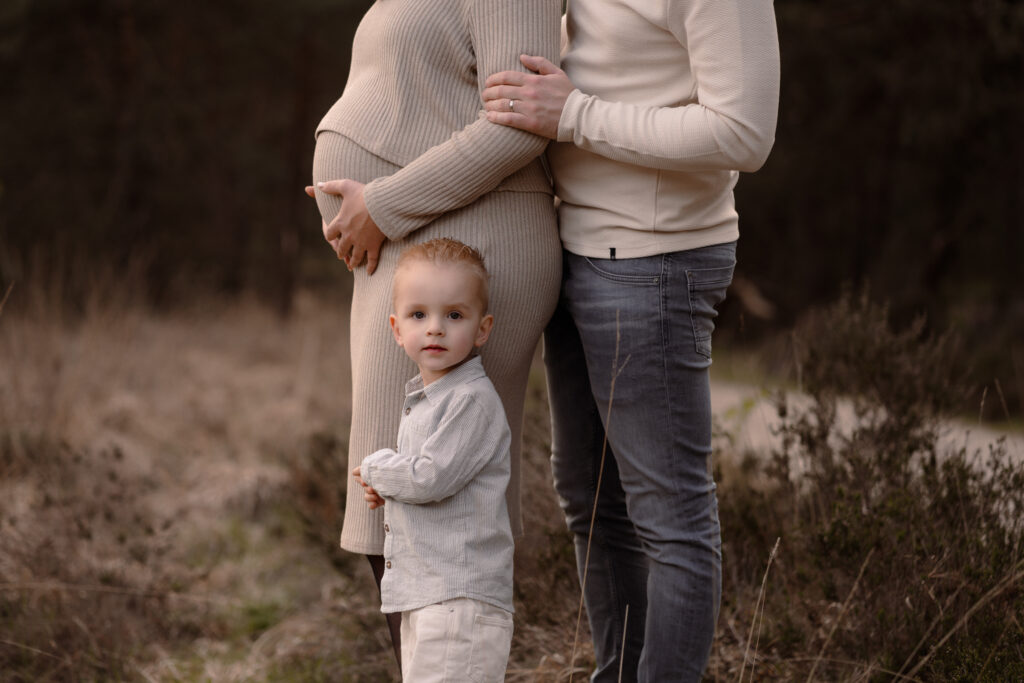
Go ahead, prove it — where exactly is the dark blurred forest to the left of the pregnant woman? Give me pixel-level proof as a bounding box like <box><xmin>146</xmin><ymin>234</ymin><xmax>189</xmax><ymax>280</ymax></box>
<box><xmin>0</xmin><ymin>0</ymin><xmax>369</xmax><ymax>311</ymax></box>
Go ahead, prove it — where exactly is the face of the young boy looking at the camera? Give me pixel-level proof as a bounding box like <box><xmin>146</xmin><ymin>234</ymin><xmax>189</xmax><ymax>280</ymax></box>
<box><xmin>390</xmin><ymin>261</ymin><xmax>495</xmax><ymax>385</ymax></box>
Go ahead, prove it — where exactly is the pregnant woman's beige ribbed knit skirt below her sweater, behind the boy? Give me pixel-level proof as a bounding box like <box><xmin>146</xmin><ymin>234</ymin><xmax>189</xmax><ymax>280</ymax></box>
<box><xmin>313</xmin><ymin>132</ymin><xmax>561</xmax><ymax>555</ymax></box>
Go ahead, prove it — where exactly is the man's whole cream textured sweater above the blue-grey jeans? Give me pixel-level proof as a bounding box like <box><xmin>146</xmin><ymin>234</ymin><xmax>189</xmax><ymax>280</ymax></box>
<box><xmin>548</xmin><ymin>0</ymin><xmax>779</xmax><ymax>258</ymax></box>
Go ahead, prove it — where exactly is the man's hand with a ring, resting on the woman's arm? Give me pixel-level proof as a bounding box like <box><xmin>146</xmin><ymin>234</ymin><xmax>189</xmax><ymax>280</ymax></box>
<box><xmin>481</xmin><ymin>54</ymin><xmax>574</xmax><ymax>140</ymax></box>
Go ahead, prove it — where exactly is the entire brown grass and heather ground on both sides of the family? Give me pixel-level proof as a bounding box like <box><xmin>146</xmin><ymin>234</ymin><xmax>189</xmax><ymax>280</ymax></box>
<box><xmin>0</xmin><ymin>295</ymin><xmax>1024</xmax><ymax>681</ymax></box>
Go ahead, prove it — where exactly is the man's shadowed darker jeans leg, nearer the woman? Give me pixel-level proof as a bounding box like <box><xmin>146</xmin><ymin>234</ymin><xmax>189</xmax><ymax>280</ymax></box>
<box><xmin>544</xmin><ymin>282</ymin><xmax>647</xmax><ymax>682</ymax></box>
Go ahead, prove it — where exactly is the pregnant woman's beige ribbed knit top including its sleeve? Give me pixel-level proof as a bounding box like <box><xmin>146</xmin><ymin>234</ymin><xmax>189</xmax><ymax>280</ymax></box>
<box><xmin>317</xmin><ymin>0</ymin><xmax>559</xmax><ymax>240</ymax></box>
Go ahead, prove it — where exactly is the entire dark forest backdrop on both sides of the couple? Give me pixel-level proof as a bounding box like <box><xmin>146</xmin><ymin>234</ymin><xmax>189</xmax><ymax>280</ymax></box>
<box><xmin>0</xmin><ymin>0</ymin><xmax>1024</xmax><ymax>418</ymax></box>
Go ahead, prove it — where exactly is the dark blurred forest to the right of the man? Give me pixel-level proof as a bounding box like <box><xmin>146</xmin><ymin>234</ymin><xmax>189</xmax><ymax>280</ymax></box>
<box><xmin>737</xmin><ymin>0</ymin><xmax>1024</xmax><ymax>416</ymax></box>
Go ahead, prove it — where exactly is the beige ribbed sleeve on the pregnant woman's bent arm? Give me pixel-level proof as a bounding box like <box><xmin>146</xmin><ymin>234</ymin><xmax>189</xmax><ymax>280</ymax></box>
<box><xmin>364</xmin><ymin>0</ymin><xmax>559</xmax><ymax>240</ymax></box>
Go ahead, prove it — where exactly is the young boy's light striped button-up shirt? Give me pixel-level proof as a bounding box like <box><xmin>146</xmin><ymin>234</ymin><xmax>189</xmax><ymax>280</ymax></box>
<box><xmin>360</xmin><ymin>356</ymin><xmax>513</xmax><ymax>612</ymax></box>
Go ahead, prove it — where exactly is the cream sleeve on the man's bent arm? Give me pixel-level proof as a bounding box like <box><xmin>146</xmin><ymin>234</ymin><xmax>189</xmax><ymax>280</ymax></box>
<box><xmin>558</xmin><ymin>0</ymin><xmax>779</xmax><ymax>172</ymax></box>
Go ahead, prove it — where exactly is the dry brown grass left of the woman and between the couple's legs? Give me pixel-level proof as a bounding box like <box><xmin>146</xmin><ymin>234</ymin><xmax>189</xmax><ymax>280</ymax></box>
<box><xmin>0</xmin><ymin>290</ymin><xmax>593</xmax><ymax>681</ymax></box>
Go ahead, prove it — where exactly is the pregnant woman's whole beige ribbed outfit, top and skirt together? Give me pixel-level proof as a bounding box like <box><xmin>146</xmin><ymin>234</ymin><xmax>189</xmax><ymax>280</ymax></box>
<box><xmin>313</xmin><ymin>0</ymin><xmax>561</xmax><ymax>555</ymax></box>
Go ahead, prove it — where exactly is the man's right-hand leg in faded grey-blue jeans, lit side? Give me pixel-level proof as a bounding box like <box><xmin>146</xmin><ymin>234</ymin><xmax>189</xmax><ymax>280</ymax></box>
<box><xmin>564</xmin><ymin>244</ymin><xmax>735</xmax><ymax>683</ymax></box>
